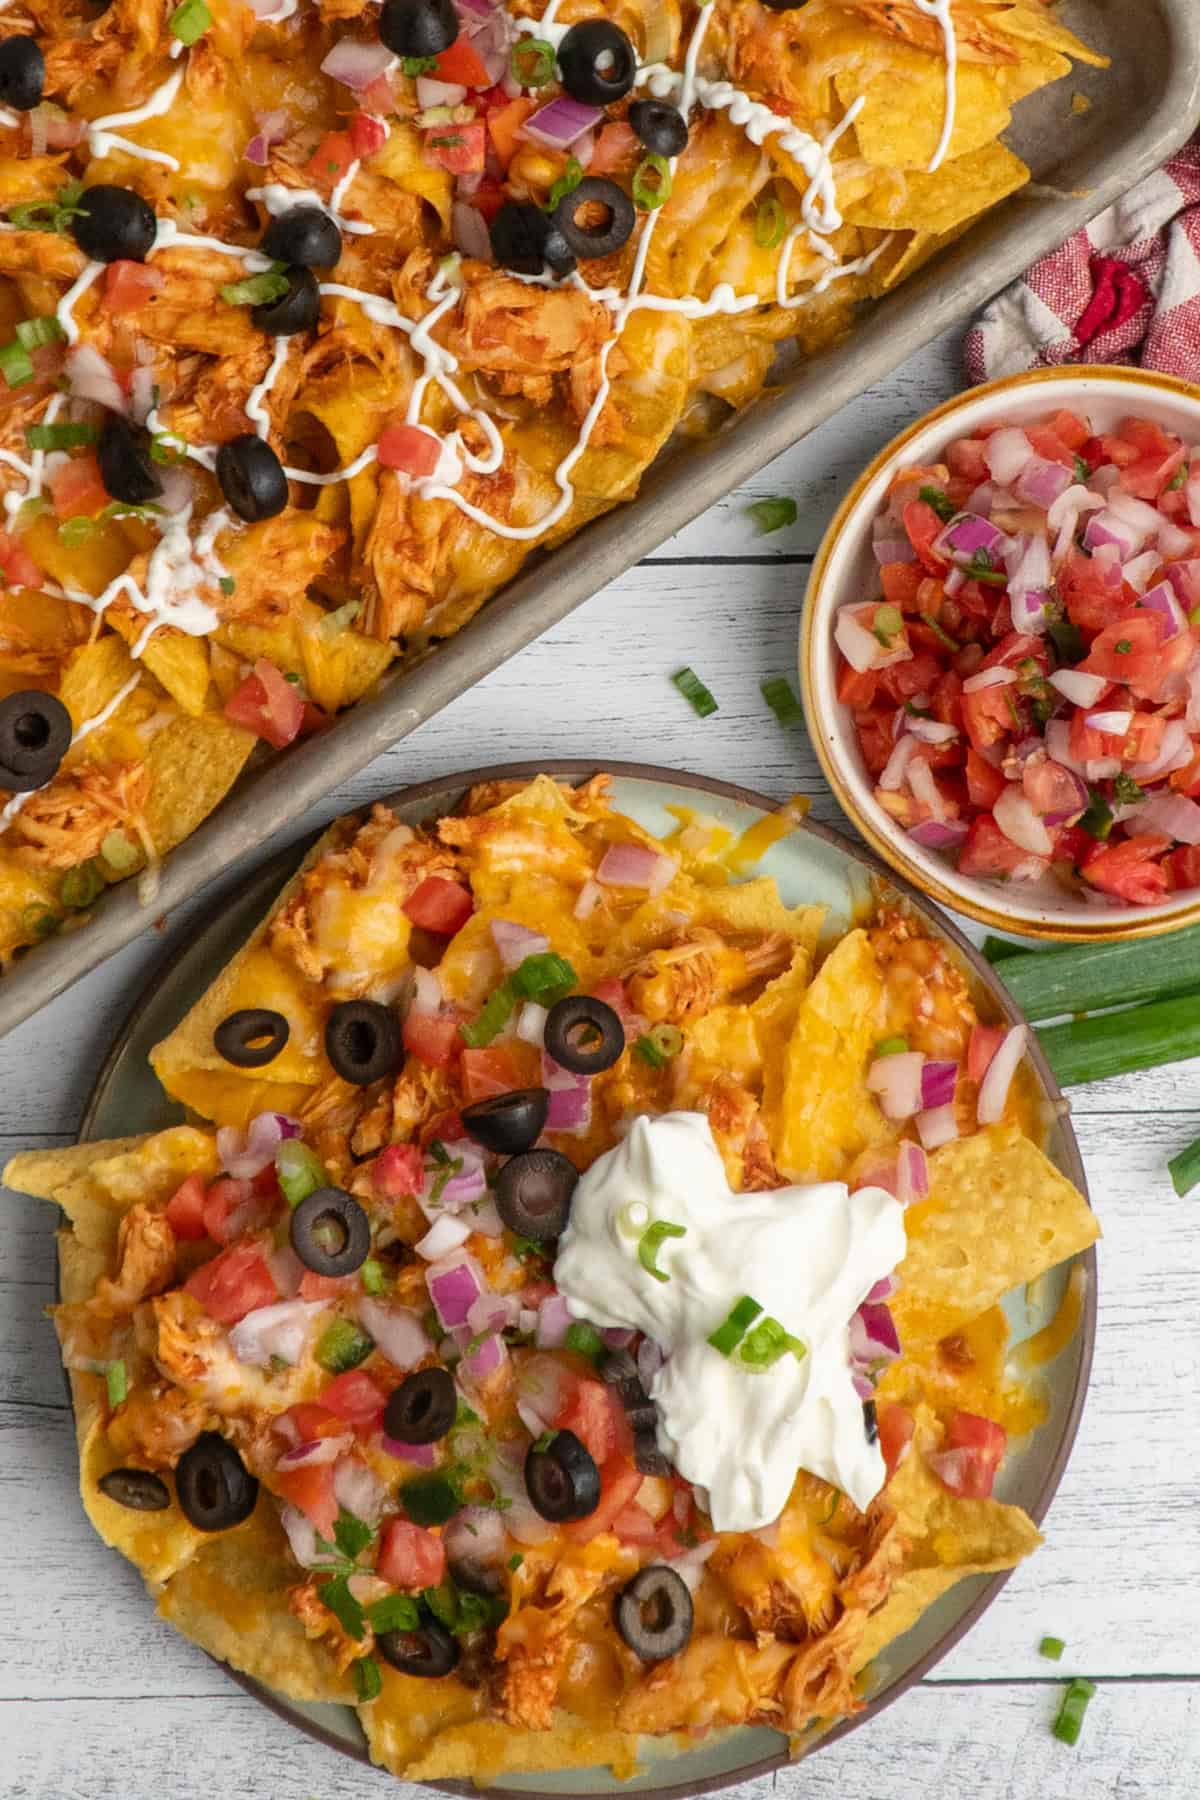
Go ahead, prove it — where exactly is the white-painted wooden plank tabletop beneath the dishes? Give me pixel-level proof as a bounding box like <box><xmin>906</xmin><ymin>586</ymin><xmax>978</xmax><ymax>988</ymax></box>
<box><xmin>0</xmin><ymin>324</ymin><xmax>1200</xmax><ymax>1800</ymax></box>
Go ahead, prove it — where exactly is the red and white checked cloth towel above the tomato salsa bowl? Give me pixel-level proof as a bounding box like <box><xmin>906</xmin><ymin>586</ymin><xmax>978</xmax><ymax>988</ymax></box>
<box><xmin>964</xmin><ymin>133</ymin><xmax>1200</xmax><ymax>382</ymax></box>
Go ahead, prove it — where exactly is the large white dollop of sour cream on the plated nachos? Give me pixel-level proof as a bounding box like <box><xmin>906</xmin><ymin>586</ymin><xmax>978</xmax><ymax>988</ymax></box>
<box><xmin>554</xmin><ymin>1112</ymin><xmax>905</xmax><ymax>1532</ymax></box>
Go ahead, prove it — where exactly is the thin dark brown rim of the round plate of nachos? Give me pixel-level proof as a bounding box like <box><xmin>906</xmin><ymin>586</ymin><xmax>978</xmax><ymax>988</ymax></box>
<box><xmin>75</xmin><ymin>758</ymin><xmax>1099</xmax><ymax>1800</ymax></box>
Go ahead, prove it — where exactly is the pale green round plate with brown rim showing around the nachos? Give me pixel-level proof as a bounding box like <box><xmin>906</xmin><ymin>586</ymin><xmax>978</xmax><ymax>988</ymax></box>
<box><xmin>81</xmin><ymin>761</ymin><xmax>1096</xmax><ymax>1800</ymax></box>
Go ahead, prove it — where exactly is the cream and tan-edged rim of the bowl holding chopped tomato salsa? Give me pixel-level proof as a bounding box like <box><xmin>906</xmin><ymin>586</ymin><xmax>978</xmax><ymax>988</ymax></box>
<box><xmin>799</xmin><ymin>362</ymin><xmax>1200</xmax><ymax>943</ymax></box>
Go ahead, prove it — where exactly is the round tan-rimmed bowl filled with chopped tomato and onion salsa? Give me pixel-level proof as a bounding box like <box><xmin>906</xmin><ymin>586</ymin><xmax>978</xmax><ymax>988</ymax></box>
<box><xmin>804</xmin><ymin>369</ymin><xmax>1200</xmax><ymax>936</ymax></box>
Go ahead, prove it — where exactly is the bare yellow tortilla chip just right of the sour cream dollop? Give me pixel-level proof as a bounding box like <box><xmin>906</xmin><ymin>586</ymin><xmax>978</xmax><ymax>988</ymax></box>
<box><xmin>891</xmin><ymin>1125</ymin><xmax>1099</xmax><ymax>1345</ymax></box>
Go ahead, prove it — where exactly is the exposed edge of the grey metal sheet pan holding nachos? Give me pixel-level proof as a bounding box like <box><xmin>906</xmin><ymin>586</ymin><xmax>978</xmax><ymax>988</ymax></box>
<box><xmin>0</xmin><ymin>0</ymin><xmax>1200</xmax><ymax>1035</ymax></box>
